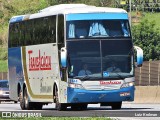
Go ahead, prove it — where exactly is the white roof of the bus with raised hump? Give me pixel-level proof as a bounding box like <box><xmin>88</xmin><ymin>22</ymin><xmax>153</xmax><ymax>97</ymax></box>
<box><xmin>9</xmin><ymin>4</ymin><xmax>127</xmax><ymax>23</ymax></box>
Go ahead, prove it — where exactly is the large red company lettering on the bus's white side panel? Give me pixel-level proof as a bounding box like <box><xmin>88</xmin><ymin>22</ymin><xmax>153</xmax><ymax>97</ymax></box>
<box><xmin>28</xmin><ymin>50</ymin><xmax>51</xmax><ymax>71</ymax></box>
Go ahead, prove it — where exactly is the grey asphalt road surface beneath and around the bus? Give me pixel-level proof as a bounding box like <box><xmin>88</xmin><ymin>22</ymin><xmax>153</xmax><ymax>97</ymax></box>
<box><xmin>0</xmin><ymin>102</ymin><xmax>160</xmax><ymax>120</ymax></box>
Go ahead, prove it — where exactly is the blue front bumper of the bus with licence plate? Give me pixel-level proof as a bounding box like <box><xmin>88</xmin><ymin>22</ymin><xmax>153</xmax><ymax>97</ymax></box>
<box><xmin>67</xmin><ymin>86</ymin><xmax>135</xmax><ymax>103</ymax></box>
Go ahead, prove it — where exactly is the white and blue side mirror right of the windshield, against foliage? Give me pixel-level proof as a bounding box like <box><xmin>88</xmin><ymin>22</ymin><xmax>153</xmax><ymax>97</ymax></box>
<box><xmin>134</xmin><ymin>46</ymin><xmax>143</xmax><ymax>67</ymax></box>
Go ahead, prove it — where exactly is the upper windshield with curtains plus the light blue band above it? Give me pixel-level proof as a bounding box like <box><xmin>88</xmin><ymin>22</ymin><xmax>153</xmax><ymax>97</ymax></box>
<box><xmin>66</xmin><ymin>13</ymin><xmax>131</xmax><ymax>39</ymax></box>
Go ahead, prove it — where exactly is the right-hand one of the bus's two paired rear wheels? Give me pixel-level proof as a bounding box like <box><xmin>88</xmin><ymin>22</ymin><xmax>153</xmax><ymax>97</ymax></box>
<box><xmin>24</xmin><ymin>87</ymin><xmax>33</xmax><ymax>110</ymax></box>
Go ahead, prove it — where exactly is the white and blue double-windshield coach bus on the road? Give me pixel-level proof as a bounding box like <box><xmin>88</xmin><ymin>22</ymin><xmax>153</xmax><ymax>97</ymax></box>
<box><xmin>8</xmin><ymin>4</ymin><xmax>143</xmax><ymax>110</ymax></box>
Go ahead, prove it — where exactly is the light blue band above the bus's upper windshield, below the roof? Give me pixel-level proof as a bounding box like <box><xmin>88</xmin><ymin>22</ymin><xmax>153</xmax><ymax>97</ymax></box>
<box><xmin>66</xmin><ymin>13</ymin><xmax>128</xmax><ymax>21</ymax></box>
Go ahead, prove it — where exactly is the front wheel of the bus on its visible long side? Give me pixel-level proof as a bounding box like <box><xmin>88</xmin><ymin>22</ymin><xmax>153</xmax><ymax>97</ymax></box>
<box><xmin>55</xmin><ymin>90</ymin><xmax>67</xmax><ymax>111</ymax></box>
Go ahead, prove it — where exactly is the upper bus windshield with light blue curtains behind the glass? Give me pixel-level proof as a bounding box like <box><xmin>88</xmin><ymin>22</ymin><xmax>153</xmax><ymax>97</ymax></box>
<box><xmin>66</xmin><ymin>20</ymin><xmax>130</xmax><ymax>39</ymax></box>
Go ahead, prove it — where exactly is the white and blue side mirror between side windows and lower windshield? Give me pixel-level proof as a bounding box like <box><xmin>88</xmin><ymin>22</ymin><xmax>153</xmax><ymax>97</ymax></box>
<box><xmin>61</xmin><ymin>47</ymin><xmax>67</xmax><ymax>68</ymax></box>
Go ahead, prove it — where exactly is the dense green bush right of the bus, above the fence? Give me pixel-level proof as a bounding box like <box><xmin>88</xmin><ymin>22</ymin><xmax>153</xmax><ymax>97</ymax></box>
<box><xmin>132</xmin><ymin>19</ymin><xmax>160</xmax><ymax>61</ymax></box>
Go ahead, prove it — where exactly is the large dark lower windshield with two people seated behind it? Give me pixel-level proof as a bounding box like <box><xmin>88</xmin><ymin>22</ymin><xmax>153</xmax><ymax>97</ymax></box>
<box><xmin>67</xmin><ymin>39</ymin><xmax>133</xmax><ymax>80</ymax></box>
